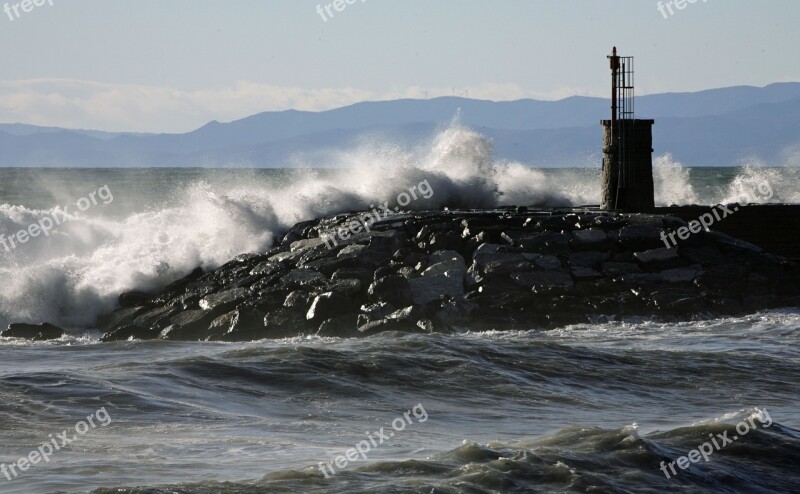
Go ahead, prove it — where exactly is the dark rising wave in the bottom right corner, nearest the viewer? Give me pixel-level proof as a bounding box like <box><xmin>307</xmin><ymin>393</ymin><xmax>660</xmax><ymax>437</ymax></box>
<box><xmin>95</xmin><ymin>413</ymin><xmax>800</xmax><ymax>494</ymax></box>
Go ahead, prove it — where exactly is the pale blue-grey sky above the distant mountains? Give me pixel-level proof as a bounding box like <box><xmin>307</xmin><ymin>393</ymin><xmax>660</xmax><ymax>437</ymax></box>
<box><xmin>0</xmin><ymin>0</ymin><xmax>800</xmax><ymax>132</ymax></box>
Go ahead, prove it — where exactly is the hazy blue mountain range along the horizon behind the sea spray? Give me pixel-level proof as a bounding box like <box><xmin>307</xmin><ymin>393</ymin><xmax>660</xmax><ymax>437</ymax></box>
<box><xmin>0</xmin><ymin>82</ymin><xmax>800</xmax><ymax>167</ymax></box>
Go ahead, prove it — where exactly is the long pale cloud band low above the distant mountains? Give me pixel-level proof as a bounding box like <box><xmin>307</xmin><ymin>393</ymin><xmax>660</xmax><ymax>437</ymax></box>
<box><xmin>0</xmin><ymin>79</ymin><xmax>600</xmax><ymax>132</ymax></box>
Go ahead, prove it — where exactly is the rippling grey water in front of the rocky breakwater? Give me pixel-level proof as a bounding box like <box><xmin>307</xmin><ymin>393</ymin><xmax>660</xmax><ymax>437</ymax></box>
<box><xmin>0</xmin><ymin>310</ymin><xmax>800</xmax><ymax>494</ymax></box>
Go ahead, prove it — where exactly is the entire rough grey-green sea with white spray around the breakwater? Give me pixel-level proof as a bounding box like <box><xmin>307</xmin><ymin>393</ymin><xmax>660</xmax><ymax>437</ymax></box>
<box><xmin>0</xmin><ymin>126</ymin><xmax>800</xmax><ymax>494</ymax></box>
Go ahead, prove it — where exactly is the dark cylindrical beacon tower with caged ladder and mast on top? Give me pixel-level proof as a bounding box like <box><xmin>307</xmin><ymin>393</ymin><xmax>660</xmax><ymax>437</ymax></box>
<box><xmin>600</xmin><ymin>47</ymin><xmax>655</xmax><ymax>213</ymax></box>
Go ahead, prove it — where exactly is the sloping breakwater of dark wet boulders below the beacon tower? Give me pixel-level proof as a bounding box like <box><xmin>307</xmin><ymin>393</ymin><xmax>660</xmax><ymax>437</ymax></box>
<box><xmin>6</xmin><ymin>208</ymin><xmax>800</xmax><ymax>341</ymax></box>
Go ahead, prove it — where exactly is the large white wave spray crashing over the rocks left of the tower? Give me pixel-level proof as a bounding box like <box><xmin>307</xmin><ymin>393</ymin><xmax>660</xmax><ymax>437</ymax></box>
<box><xmin>0</xmin><ymin>124</ymin><xmax>590</xmax><ymax>328</ymax></box>
